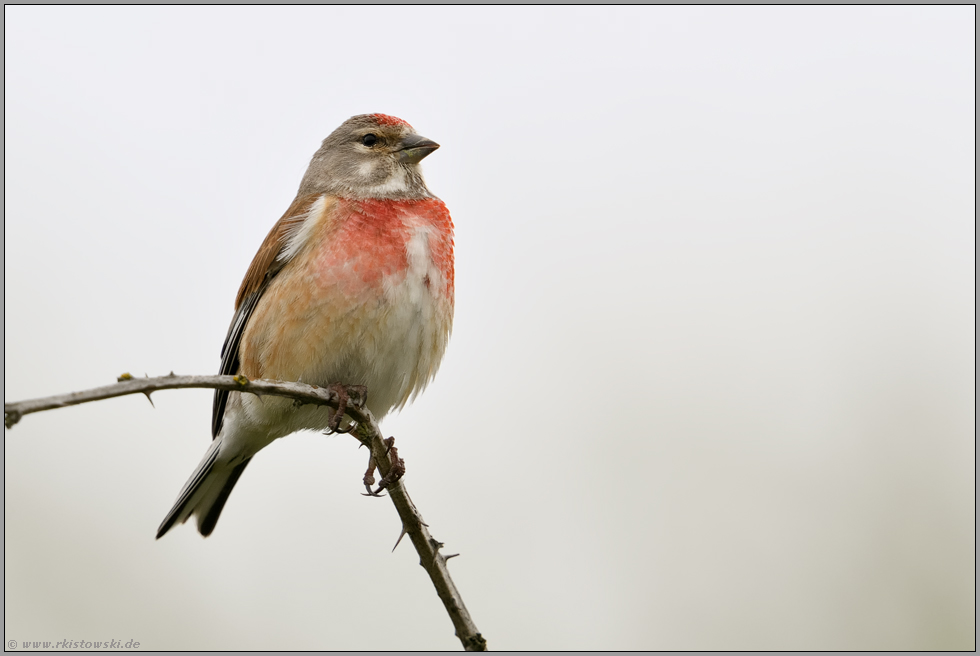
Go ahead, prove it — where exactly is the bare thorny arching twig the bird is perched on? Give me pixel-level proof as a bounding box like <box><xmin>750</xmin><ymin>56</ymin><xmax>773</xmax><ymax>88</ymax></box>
<box><xmin>3</xmin><ymin>373</ymin><xmax>487</xmax><ymax>651</ymax></box>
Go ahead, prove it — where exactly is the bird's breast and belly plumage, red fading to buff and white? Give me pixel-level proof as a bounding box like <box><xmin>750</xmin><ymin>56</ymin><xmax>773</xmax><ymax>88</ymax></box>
<box><xmin>240</xmin><ymin>198</ymin><xmax>454</xmax><ymax>420</ymax></box>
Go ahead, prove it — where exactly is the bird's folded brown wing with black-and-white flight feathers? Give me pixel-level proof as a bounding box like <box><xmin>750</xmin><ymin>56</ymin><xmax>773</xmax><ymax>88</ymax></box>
<box><xmin>211</xmin><ymin>194</ymin><xmax>319</xmax><ymax>439</ymax></box>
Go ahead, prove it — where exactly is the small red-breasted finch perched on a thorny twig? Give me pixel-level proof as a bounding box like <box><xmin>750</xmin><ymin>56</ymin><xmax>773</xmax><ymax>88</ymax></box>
<box><xmin>157</xmin><ymin>114</ymin><xmax>454</xmax><ymax>538</ymax></box>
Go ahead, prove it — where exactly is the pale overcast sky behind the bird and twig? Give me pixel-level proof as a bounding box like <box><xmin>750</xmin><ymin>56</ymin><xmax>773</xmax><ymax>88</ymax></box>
<box><xmin>4</xmin><ymin>6</ymin><xmax>976</xmax><ymax>650</ymax></box>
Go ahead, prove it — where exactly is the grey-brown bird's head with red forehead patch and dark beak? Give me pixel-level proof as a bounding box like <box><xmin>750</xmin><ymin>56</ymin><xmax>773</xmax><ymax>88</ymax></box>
<box><xmin>298</xmin><ymin>114</ymin><xmax>439</xmax><ymax>199</ymax></box>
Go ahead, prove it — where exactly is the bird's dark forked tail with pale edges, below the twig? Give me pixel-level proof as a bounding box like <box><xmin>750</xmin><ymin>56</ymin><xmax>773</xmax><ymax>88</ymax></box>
<box><xmin>157</xmin><ymin>436</ymin><xmax>251</xmax><ymax>540</ymax></box>
